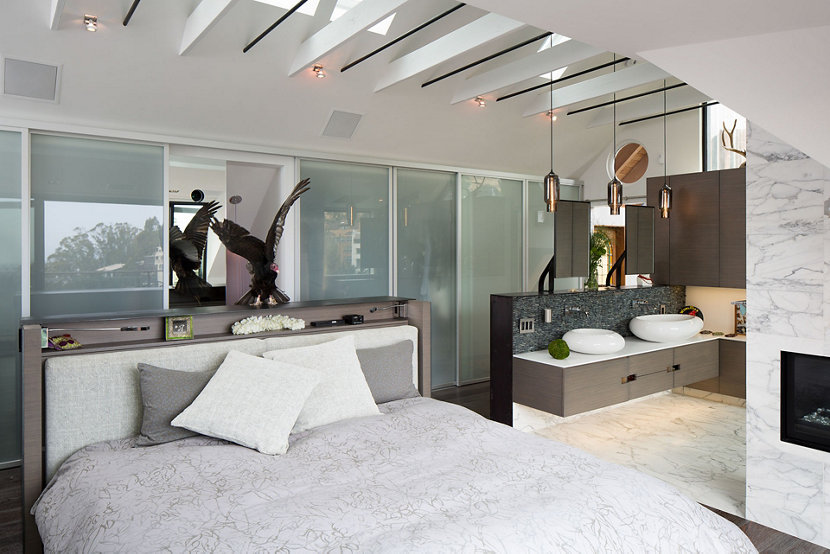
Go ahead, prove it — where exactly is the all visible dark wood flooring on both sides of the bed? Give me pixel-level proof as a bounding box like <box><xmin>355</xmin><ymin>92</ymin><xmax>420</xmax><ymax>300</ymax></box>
<box><xmin>0</xmin><ymin>383</ymin><xmax>830</xmax><ymax>554</ymax></box>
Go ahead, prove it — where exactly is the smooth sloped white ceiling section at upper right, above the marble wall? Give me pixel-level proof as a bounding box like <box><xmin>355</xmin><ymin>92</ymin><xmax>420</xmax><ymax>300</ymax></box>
<box><xmin>470</xmin><ymin>0</ymin><xmax>830</xmax><ymax>166</ymax></box>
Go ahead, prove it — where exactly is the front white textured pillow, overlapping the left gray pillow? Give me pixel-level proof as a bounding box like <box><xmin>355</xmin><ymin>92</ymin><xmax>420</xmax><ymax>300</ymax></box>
<box><xmin>170</xmin><ymin>350</ymin><xmax>320</xmax><ymax>454</ymax></box>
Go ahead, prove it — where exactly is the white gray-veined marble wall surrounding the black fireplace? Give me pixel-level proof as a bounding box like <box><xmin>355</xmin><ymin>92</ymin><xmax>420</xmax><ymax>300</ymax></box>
<box><xmin>746</xmin><ymin>119</ymin><xmax>830</xmax><ymax>547</ymax></box>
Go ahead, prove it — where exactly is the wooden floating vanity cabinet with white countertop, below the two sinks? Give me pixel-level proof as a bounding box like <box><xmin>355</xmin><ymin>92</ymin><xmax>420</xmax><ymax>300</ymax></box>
<box><xmin>512</xmin><ymin>335</ymin><xmax>741</xmax><ymax>416</ymax></box>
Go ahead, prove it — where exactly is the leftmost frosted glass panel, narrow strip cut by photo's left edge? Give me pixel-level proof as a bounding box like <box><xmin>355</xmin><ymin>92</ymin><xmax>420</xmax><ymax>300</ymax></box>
<box><xmin>0</xmin><ymin>131</ymin><xmax>21</xmax><ymax>469</ymax></box>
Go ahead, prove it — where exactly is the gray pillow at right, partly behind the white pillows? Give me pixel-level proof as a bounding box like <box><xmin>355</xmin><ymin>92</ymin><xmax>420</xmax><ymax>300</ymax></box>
<box><xmin>357</xmin><ymin>340</ymin><xmax>420</xmax><ymax>404</ymax></box>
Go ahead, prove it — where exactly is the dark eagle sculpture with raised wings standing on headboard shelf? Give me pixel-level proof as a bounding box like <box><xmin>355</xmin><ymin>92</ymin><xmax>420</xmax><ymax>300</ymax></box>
<box><xmin>210</xmin><ymin>179</ymin><xmax>310</xmax><ymax>306</ymax></box>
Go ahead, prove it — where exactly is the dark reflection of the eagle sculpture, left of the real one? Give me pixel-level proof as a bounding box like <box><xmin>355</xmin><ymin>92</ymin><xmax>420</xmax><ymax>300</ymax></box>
<box><xmin>170</xmin><ymin>201</ymin><xmax>220</xmax><ymax>302</ymax></box>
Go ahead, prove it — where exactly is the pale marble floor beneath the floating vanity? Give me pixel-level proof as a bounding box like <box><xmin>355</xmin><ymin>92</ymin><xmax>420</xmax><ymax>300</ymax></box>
<box><xmin>519</xmin><ymin>392</ymin><xmax>746</xmax><ymax>517</ymax></box>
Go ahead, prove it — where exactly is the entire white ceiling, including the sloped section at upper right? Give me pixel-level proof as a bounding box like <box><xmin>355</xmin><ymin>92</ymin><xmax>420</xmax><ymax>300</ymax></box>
<box><xmin>0</xmin><ymin>0</ymin><xmax>830</xmax><ymax>172</ymax></box>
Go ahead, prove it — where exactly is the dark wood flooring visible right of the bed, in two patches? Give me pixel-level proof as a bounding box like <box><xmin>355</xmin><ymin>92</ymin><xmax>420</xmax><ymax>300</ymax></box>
<box><xmin>432</xmin><ymin>382</ymin><xmax>830</xmax><ymax>554</ymax></box>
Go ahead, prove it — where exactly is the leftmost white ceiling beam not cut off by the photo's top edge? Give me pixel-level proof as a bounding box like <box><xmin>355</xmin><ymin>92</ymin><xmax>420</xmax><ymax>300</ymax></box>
<box><xmin>375</xmin><ymin>13</ymin><xmax>524</xmax><ymax>92</ymax></box>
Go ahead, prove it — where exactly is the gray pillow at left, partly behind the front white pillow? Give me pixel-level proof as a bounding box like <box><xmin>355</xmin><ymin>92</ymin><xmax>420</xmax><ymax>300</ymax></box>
<box><xmin>135</xmin><ymin>364</ymin><xmax>216</xmax><ymax>446</ymax></box>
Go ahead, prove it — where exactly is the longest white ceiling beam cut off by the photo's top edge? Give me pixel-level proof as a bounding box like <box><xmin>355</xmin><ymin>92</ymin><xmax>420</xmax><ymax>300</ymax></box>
<box><xmin>288</xmin><ymin>0</ymin><xmax>407</xmax><ymax>77</ymax></box>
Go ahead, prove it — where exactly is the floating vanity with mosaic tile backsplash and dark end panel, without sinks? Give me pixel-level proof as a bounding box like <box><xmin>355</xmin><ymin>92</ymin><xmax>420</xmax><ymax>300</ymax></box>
<box><xmin>490</xmin><ymin>286</ymin><xmax>746</xmax><ymax>425</ymax></box>
